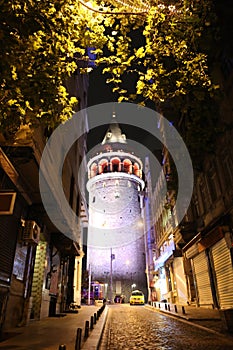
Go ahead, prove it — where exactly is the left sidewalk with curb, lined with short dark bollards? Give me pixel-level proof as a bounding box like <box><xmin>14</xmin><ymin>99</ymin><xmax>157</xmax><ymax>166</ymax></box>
<box><xmin>0</xmin><ymin>305</ymin><xmax>108</xmax><ymax>350</ymax></box>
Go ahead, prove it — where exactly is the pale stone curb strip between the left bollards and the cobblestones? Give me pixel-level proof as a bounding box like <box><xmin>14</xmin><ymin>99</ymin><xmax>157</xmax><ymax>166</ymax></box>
<box><xmin>81</xmin><ymin>306</ymin><xmax>108</xmax><ymax>350</ymax></box>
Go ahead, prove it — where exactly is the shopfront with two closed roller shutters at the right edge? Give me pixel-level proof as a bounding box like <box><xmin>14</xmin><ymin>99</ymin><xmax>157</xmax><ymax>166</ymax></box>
<box><xmin>183</xmin><ymin>226</ymin><xmax>233</xmax><ymax>309</ymax></box>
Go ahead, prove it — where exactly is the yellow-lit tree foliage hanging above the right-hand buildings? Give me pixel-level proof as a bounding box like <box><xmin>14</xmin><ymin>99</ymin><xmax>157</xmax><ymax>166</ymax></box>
<box><xmin>100</xmin><ymin>0</ymin><xmax>221</xmax><ymax>154</ymax></box>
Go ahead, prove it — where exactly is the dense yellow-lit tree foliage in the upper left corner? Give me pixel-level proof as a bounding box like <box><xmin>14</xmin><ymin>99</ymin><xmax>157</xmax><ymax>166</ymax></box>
<box><xmin>0</xmin><ymin>0</ymin><xmax>106</xmax><ymax>132</ymax></box>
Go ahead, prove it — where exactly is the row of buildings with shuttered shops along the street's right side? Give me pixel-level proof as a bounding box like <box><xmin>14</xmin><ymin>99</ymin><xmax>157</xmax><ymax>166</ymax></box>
<box><xmin>150</xmin><ymin>2</ymin><xmax>233</xmax><ymax>324</ymax></box>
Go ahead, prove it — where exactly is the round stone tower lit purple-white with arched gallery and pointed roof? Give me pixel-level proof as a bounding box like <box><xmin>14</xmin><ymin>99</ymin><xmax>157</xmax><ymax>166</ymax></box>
<box><xmin>87</xmin><ymin>115</ymin><xmax>147</xmax><ymax>302</ymax></box>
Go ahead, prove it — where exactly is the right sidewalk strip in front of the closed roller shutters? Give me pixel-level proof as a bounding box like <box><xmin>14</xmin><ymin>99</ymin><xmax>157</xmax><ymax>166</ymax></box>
<box><xmin>146</xmin><ymin>302</ymin><xmax>233</xmax><ymax>338</ymax></box>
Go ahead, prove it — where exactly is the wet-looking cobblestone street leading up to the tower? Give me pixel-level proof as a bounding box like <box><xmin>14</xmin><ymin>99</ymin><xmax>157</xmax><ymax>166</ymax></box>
<box><xmin>99</xmin><ymin>304</ymin><xmax>233</xmax><ymax>350</ymax></box>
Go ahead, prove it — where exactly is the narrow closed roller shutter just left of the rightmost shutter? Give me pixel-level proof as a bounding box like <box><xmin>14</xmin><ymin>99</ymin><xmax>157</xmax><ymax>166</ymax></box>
<box><xmin>193</xmin><ymin>251</ymin><xmax>213</xmax><ymax>306</ymax></box>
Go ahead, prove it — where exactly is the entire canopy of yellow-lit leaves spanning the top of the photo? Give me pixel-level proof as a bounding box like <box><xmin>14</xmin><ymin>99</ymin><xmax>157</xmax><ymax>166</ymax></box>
<box><xmin>0</xmin><ymin>0</ymin><xmax>222</xmax><ymax>156</ymax></box>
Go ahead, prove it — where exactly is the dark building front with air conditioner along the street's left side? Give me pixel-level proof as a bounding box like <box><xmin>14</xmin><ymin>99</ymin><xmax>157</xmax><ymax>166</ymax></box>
<box><xmin>0</xmin><ymin>74</ymin><xmax>88</xmax><ymax>337</ymax></box>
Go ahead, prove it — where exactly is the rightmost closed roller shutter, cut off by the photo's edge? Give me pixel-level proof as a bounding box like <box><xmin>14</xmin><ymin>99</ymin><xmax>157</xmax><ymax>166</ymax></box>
<box><xmin>211</xmin><ymin>238</ymin><xmax>233</xmax><ymax>309</ymax></box>
